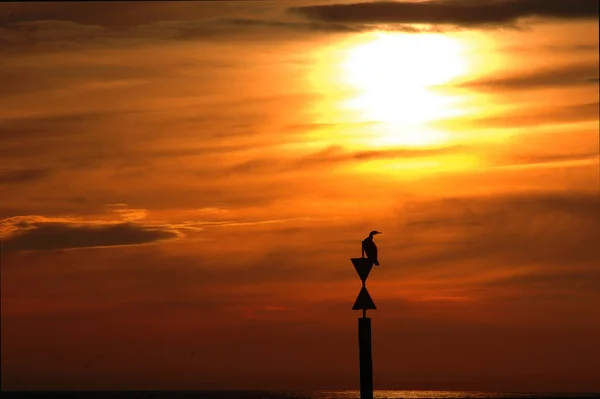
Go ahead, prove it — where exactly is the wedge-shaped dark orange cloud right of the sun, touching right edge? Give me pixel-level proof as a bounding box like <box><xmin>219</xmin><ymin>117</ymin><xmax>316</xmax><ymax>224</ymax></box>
<box><xmin>460</xmin><ymin>61</ymin><xmax>598</xmax><ymax>90</ymax></box>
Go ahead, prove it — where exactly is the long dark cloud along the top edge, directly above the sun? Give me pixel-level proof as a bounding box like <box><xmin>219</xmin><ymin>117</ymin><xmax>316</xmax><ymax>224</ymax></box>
<box><xmin>290</xmin><ymin>0</ymin><xmax>598</xmax><ymax>26</ymax></box>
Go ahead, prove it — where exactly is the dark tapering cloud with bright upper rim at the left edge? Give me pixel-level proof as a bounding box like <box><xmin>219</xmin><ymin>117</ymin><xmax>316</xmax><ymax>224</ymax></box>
<box><xmin>2</xmin><ymin>216</ymin><xmax>178</xmax><ymax>252</ymax></box>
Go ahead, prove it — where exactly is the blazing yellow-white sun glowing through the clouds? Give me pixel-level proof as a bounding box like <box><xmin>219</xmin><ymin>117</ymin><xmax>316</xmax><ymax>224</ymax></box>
<box><xmin>341</xmin><ymin>32</ymin><xmax>467</xmax><ymax>146</ymax></box>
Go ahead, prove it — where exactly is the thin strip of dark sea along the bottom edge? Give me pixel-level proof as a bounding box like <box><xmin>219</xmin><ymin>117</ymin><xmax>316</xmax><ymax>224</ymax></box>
<box><xmin>1</xmin><ymin>390</ymin><xmax>600</xmax><ymax>399</ymax></box>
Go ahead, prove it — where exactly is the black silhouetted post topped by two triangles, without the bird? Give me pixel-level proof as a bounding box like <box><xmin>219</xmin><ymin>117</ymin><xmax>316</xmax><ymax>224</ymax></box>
<box><xmin>350</xmin><ymin>258</ymin><xmax>377</xmax><ymax>399</ymax></box>
